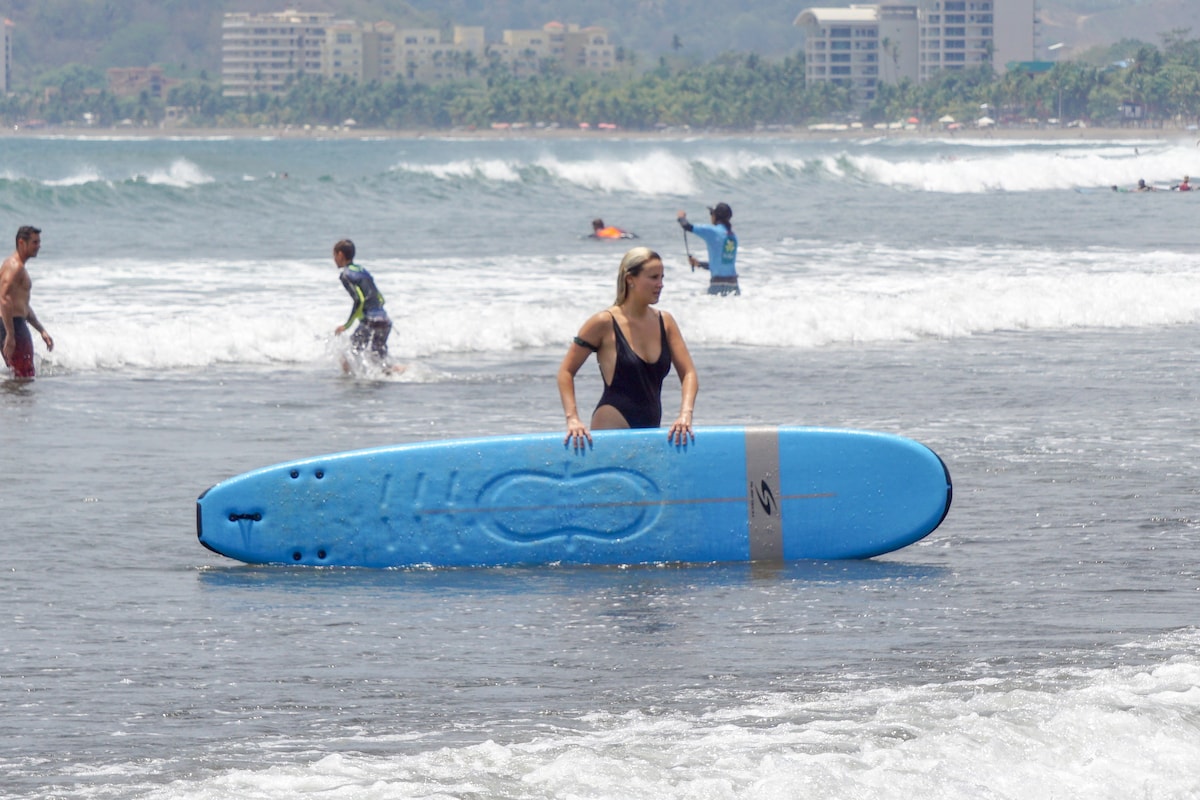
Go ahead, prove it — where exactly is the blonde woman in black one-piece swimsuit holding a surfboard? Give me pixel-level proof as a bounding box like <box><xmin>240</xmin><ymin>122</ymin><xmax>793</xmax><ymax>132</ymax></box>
<box><xmin>558</xmin><ymin>247</ymin><xmax>700</xmax><ymax>450</ymax></box>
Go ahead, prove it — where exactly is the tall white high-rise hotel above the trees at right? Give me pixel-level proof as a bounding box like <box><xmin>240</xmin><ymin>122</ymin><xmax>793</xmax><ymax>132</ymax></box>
<box><xmin>794</xmin><ymin>0</ymin><xmax>1037</xmax><ymax>106</ymax></box>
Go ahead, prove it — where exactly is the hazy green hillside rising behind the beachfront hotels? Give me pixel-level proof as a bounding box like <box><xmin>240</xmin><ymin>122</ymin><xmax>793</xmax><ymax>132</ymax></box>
<box><xmin>0</xmin><ymin>0</ymin><xmax>1200</xmax><ymax>86</ymax></box>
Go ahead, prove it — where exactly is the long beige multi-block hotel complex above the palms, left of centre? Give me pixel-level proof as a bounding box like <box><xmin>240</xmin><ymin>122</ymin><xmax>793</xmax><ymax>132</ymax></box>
<box><xmin>221</xmin><ymin>11</ymin><xmax>616</xmax><ymax>97</ymax></box>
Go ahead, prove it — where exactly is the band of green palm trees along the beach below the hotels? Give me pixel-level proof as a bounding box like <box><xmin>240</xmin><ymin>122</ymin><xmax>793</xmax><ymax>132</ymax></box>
<box><xmin>7</xmin><ymin>31</ymin><xmax>1200</xmax><ymax>130</ymax></box>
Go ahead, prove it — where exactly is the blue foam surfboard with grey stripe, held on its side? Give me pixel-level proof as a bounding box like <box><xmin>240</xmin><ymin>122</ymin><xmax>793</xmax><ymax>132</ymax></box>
<box><xmin>196</xmin><ymin>427</ymin><xmax>952</xmax><ymax>567</ymax></box>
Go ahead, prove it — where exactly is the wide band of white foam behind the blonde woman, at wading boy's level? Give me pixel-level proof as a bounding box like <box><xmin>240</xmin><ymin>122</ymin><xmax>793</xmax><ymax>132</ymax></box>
<box><xmin>38</xmin><ymin>242</ymin><xmax>1200</xmax><ymax>369</ymax></box>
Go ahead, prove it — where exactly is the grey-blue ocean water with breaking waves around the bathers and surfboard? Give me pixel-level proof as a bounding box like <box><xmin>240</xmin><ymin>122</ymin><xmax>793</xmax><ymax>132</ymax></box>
<box><xmin>0</xmin><ymin>131</ymin><xmax>1200</xmax><ymax>800</ymax></box>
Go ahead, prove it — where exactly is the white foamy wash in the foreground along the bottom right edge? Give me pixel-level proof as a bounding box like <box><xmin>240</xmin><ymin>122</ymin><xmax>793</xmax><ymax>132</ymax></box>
<box><xmin>124</xmin><ymin>636</ymin><xmax>1200</xmax><ymax>800</ymax></box>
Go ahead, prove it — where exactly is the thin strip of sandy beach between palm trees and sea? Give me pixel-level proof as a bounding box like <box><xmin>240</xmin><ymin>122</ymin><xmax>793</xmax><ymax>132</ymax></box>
<box><xmin>5</xmin><ymin>126</ymin><xmax>1200</xmax><ymax>145</ymax></box>
